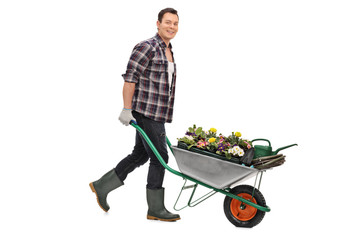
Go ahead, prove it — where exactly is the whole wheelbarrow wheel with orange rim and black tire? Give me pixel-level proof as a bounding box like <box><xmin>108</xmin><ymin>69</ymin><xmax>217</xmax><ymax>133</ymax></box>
<box><xmin>224</xmin><ymin>185</ymin><xmax>266</xmax><ymax>228</ymax></box>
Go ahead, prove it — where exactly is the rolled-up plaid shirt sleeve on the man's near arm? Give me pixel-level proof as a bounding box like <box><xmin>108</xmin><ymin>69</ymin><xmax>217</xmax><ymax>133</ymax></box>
<box><xmin>122</xmin><ymin>42</ymin><xmax>154</xmax><ymax>83</ymax></box>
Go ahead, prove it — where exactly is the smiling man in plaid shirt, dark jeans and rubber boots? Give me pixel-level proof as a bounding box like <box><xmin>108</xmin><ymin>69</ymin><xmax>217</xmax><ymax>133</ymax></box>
<box><xmin>90</xmin><ymin>8</ymin><xmax>180</xmax><ymax>221</ymax></box>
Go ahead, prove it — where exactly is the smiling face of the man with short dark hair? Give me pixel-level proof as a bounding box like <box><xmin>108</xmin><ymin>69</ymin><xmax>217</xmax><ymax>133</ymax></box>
<box><xmin>156</xmin><ymin>13</ymin><xmax>179</xmax><ymax>41</ymax></box>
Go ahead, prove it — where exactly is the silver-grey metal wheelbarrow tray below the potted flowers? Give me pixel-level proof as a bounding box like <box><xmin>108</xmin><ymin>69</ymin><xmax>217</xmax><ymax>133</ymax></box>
<box><xmin>172</xmin><ymin>146</ymin><xmax>259</xmax><ymax>189</ymax></box>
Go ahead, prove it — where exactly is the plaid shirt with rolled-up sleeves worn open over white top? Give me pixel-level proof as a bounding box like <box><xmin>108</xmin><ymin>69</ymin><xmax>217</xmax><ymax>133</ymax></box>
<box><xmin>122</xmin><ymin>34</ymin><xmax>176</xmax><ymax>123</ymax></box>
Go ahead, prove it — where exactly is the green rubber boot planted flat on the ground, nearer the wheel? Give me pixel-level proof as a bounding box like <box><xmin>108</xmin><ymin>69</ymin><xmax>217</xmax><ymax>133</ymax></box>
<box><xmin>146</xmin><ymin>188</ymin><xmax>180</xmax><ymax>222</ymax></box>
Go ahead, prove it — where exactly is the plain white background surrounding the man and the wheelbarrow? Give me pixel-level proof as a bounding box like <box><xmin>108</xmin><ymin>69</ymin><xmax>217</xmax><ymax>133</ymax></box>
<box><xmin>0</xmin><ymin>0</ymin><xmax>360</xmax><ymax>239</ymax></box>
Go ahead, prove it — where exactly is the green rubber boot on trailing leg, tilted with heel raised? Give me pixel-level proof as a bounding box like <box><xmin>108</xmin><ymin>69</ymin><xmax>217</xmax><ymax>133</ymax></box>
<box><xmin>89</xmin><ymin>169</ymin><xmax>124</xmax><ymax>212</ymax></box>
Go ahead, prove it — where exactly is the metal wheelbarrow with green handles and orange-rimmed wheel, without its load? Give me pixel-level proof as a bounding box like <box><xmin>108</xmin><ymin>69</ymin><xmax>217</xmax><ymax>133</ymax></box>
<box><xmin>131</xmin><ymin>122</ymin><xmax>294</xmax><ymax>228</ymax></box>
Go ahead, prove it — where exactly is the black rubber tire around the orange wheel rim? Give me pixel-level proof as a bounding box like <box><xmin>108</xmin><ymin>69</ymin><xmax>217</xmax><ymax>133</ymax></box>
<box><xmin>224</xmin><ymin>185</ymin><xmax>266</xmax><ymax>228</ymax></box>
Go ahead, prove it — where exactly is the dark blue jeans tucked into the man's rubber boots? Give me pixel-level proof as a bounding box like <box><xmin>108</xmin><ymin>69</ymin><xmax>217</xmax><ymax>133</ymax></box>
<box><xmin>115</xmin><ymin>111</ymin><xmax>169</xmax><ymax>189</ymax></box>
